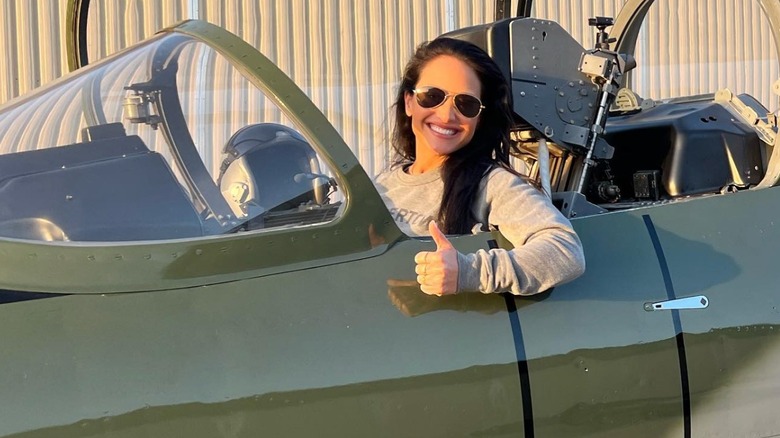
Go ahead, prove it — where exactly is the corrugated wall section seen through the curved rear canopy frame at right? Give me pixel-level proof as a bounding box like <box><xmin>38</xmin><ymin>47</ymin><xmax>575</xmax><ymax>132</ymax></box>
<box><xmin>634</xmin><ymin>0</ymin><xmax>780</xmax><ymax>102</ymax></box>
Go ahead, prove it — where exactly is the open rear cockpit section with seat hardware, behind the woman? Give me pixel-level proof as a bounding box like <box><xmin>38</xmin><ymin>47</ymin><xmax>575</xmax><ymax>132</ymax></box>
<box><xmin>450</xmin><ymin>7</ymin><xmax>780</xmax><ymax>217</ymax></box>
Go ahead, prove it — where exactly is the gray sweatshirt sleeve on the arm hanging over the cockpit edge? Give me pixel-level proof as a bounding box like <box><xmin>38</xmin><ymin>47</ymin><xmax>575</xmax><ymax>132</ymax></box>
<box><xmin>458</xmin><ymin>169</ymin><xmax>585</xmax><ymax>295</ymax></box>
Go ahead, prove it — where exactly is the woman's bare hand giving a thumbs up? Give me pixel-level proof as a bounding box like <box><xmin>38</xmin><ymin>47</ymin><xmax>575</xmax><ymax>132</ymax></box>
<box><xmin>414</xmin><ymin>221</ymin><xmax>458</xmax><ymax>296</ymax></box>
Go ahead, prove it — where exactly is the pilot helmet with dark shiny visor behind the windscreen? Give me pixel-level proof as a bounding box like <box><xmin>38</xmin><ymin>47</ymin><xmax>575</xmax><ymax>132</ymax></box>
<box><xmin>217</xmin><ymin>123</ymin><xmax>331</xmax><ymax>228</ymax></box>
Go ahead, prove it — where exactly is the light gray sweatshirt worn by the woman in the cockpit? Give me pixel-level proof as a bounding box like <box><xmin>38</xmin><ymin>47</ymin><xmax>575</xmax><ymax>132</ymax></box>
<box><xmin>376</xmin><ymin>166</ymin><xmax>585</xmax><ymax>295</ymax></box>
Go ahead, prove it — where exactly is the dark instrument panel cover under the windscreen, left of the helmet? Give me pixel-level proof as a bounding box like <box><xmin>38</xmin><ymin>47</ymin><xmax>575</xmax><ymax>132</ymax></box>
<box><xmin>0</xmin><ymin>136</ymin><xmax>203</xmax><ymax>241</ymax></box>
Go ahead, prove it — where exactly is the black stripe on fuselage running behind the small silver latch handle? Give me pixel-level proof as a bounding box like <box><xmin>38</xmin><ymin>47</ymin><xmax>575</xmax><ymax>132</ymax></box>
<box><xmin>642</xmin><ymin>214</ymin><xmax>691</xmax><ymax>438</ymax></box>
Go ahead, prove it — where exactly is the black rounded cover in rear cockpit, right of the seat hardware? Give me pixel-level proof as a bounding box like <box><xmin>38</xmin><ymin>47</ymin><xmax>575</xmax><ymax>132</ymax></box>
<box><xmin>604</xmin><ymin>101</ymin><xmax>764</xmax><ymax>197</ymax></box>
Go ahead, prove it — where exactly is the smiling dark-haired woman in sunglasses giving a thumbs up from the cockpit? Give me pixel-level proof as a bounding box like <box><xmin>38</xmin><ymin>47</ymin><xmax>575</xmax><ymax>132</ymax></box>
<box><xmin>376</xmin><ymin>38</ymin><xmax>585</xmax><ymax>295</ymax></box>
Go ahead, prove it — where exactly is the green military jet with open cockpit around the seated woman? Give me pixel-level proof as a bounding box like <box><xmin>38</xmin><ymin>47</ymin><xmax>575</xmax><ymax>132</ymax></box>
<box><xmin>0</xmin><ymin>0</ymin><xmax>780</xmax><ymax>437</ymax></box>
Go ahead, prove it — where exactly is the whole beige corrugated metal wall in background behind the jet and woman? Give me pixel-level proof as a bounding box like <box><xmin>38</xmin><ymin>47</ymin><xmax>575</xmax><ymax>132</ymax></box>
<box><xmin>0</xmin><ymin>0</ymin><xmax>780</xmax><ymax>175</ymax></box>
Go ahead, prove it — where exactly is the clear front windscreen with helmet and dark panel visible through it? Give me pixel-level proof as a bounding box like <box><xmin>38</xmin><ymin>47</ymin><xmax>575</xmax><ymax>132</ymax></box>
<box><xmin>0</xmin><ymin>30</ymin><xmax>343</xmax><ymax>241</ymax></box>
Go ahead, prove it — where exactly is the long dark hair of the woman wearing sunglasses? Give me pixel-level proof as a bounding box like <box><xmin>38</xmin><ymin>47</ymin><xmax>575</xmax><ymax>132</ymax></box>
<box><xmin>392</xmin><ymin>38</ymin><xmax>517</xmax><ymax>234</ymax></box>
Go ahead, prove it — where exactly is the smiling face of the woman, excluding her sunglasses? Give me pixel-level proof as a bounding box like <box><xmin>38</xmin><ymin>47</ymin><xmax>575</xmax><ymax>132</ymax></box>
<box><xmin>405</xmin><ymin>55</ymin><xmax>482</xmax><ymax>160</ymax></box>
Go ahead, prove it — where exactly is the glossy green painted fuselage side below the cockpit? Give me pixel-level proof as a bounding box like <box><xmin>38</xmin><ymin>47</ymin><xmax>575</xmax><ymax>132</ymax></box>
<box><xmin>6</xmin><ymin>189</ymin><xmax>780</xmax><ymax>437</ymax></box>
